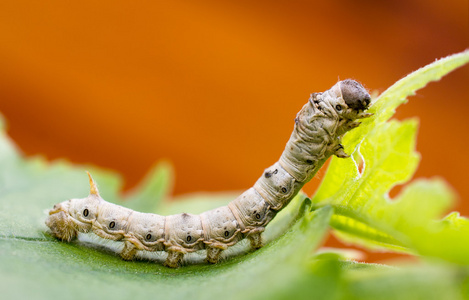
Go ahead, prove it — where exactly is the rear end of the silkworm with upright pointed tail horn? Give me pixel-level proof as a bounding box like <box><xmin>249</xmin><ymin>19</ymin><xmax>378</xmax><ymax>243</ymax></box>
<box><xmin>46</xmin><ymin>173</ymin><xmax>101</xmax><ymax>241</ymax></box>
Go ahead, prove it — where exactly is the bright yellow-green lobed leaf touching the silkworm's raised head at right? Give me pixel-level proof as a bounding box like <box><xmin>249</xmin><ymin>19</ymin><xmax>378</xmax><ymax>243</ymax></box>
<box><xmin>313</xmin><ymin>51</ymin><xmax>469</xmax><ymax>264</ymax></box>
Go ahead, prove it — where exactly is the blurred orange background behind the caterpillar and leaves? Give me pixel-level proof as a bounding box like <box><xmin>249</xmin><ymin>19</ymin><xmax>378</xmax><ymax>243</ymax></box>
<box><xmin>0</xmin><ymin>0</ymin><xmax>469</xmax><ymax>260</ymax></box>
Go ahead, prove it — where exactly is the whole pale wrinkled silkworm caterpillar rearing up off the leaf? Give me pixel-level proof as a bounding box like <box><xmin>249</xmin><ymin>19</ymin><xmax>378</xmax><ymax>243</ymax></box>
<box><xmin>46</xmin><ymin>80</ymin><xmax>371</xmax><ymax>268</ymax></box>
